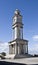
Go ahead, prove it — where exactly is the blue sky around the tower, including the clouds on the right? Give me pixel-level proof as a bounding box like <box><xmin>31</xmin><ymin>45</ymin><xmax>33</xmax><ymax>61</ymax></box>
<box><xmin>0</xmin><ymin>0</ymin><xmax>38</xmax><ymax>54</ymax></box>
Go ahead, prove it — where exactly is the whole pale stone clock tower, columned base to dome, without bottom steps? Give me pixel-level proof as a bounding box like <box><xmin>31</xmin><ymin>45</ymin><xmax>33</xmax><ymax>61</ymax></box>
<box><xmin>9</xmin><ymin>9</ymin><xmax>28</xmax><ymax>58</ymax></box>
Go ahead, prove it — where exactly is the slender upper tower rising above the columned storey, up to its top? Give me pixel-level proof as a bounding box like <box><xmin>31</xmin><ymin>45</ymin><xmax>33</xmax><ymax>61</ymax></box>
<box><xmin>12</xmin><ymin>9</ymin><xmax>23</xmax><ymax>40</ymax></box>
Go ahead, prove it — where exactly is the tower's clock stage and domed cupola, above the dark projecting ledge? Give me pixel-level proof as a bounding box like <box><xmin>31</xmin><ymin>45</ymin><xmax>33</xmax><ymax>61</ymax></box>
<box><xmin>13</xmin><ymin>9</ymin><xmax>22</xmax><ymax>24</ymax></box>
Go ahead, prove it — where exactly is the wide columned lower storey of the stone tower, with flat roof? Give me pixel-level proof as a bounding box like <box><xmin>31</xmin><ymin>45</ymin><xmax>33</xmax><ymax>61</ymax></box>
<box><xmin>9</xmin><ymin>39</ymin><xmax>28</xmax><ymax>55</ymax></box>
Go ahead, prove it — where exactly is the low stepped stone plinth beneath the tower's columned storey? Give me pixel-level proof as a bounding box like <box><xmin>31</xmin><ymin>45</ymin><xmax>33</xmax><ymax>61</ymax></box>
<box><xmin>5</xmin><ymin>54</ymin><xmax>33</xmax><ymax>59</ymax></box>
